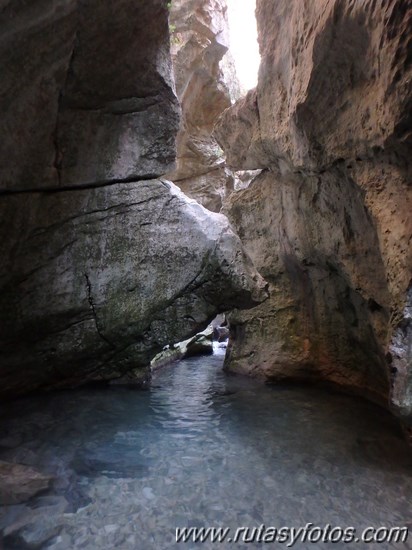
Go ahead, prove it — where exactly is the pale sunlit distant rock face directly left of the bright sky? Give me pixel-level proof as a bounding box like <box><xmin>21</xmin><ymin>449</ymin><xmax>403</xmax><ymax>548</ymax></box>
<box><xmin>168</xmin><ymin>0</ymin><xmax>239</xmax><ymax>212</ymax></box>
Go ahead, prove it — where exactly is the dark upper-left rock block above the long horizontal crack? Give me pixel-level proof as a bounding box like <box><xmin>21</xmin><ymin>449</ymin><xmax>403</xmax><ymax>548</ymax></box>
<box><xmin>0</xmin><ymin>0</ymin><xmax>179</xmax><ymax>190</ymax></box>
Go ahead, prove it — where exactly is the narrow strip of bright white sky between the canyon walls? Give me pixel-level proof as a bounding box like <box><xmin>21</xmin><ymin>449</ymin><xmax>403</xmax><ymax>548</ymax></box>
<box><xmin>227</xmin><ymin>0</ymin><xmax>260</xmax><ymax>90</ymax></box>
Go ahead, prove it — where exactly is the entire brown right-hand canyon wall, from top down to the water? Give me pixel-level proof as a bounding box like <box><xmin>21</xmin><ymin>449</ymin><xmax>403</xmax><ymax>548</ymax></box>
<box><xmin>216</xmin><ymin>0</ymin><xmax>412</xmax><ymax>421</ymax></box>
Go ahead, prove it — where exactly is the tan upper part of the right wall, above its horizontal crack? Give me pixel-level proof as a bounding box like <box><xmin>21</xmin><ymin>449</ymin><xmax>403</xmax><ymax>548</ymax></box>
<box><xmin>221</xmin><ymin>0</ymin><xmax>412</xmax><ymax>170</ymax></box>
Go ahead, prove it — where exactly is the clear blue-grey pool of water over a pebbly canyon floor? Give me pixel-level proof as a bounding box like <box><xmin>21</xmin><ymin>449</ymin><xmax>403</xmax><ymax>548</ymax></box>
<box><xmin>0</xmin><ymin>351</ymin><xmax>412</xmax><ymax>550</ymax></box>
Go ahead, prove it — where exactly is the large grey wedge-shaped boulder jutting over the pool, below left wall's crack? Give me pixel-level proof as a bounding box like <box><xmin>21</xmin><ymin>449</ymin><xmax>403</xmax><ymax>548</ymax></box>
<box><xmin>0</xmin><ymin>180</ymin><xmax>265</xmax><ymax>396</ymax></box>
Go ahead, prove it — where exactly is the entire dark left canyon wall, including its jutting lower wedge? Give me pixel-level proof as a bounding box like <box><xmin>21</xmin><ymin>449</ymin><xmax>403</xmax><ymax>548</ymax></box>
<box><xmin>0</xmin><ymin>0</ymin><xmax>264</xmax><ymax>396</ymax></box>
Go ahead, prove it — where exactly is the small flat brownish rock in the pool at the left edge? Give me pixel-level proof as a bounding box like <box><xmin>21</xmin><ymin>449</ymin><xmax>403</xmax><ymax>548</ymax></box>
<box><xmin>0</xmin><ymin>460</ymin><xmax>53</xmax><ymax>506</ymax></box>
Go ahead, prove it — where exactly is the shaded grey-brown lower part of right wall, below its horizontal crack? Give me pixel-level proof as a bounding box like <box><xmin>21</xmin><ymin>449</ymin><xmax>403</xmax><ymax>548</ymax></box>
<box><xmin>226</xmin><ymin>172</ymin><xmax>390</xmax><ymax>402</ymax></box>
